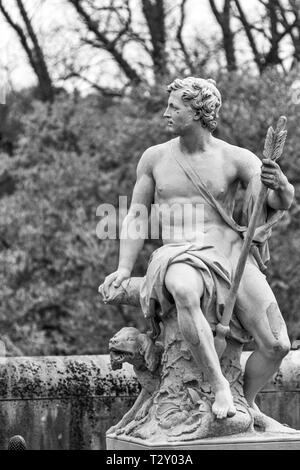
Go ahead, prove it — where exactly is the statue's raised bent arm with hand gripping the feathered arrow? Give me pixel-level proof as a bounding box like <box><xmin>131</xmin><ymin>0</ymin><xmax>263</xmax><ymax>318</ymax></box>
<box><xmin>236</xmin><ymin>149</ymin><xmax>294</xmax><ymax>210</ymax></box>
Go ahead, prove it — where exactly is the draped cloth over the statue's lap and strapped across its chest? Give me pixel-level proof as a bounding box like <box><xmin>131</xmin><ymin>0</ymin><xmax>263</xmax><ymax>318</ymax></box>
<box><xmin>140</xmin><ymin>145</ymin><xmax>283</xmax><ymax>343</ymax></box>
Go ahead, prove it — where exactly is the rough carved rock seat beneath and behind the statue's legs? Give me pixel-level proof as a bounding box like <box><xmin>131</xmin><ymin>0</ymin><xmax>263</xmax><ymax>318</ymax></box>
<box><xmin>108</xmin><ymin>309</ymin><xmax>254</xmax><ymax>442</ymax></box>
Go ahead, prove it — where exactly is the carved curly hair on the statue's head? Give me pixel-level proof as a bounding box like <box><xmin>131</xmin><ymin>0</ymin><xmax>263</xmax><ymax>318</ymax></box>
<box><xmin>167</xmin><ymin>77</ymin><xmax>222</xmax><ymax>132</ymax></box>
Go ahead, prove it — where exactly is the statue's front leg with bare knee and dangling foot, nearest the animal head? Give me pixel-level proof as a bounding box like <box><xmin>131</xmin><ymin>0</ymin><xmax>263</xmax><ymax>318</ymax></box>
<box><xmin>165</xmin><ymin>263</ymin><xmax>236</xmax><ymax>419</ymax></box>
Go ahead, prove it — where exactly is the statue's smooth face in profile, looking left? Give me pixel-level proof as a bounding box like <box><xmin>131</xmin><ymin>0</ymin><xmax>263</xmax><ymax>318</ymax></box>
<box><xmin>163</xmin><ymin>90</ymin><xmax>196</xmax><ymax>136</ymax></box>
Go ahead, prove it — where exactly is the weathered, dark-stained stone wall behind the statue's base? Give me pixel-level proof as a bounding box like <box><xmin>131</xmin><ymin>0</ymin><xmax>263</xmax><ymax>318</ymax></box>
<box><xmin>0</xmin><ymin>351</ymin><xmax>300</xmax><ymax>450</ymax></box>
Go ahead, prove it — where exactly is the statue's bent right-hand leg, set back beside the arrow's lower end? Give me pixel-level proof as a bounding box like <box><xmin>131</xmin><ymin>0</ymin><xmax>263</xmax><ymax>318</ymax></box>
<box><xmin>236</xmin><ymin>263</ymin><xmax>290</xmax><ymax>408</ymax></box>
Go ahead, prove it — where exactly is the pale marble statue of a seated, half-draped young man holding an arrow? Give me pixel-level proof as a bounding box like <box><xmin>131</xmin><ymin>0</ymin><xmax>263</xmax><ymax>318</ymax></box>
<box><xmin>99</xmin><ymin>77</ymin><xmax>294</xmax><ymax>442</ymax></box>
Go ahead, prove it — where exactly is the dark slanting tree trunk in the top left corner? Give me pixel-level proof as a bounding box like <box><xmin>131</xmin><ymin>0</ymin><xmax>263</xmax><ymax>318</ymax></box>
<box><xmin>0</xmin><ymin>0</ymin><xmax>54</xmax><ymax>101</ymax></box>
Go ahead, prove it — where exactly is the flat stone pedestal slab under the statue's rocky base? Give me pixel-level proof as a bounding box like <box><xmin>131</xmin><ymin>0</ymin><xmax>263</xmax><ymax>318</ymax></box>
<box><xmin>106</xmin><ymin>432</ymin><xmax>300</xmax><ymax>451</ymax></box>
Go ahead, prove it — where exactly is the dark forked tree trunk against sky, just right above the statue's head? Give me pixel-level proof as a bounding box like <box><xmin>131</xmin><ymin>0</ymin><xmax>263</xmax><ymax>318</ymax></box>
<box><xmin>209</xmin><ymin>0</ymin><xmax>237</xmax><ymax>71</ymax></box>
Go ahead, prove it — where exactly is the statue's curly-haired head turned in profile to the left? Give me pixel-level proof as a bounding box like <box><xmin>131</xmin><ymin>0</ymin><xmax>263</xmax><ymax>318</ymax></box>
<box><xmin>164</xmin><ymin>77</ymin><xmax>222</xmax><ymax>135</ymax></box>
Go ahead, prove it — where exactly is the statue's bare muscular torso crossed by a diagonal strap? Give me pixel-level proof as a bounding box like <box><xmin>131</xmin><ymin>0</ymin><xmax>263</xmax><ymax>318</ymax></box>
<box><xmin>153</xmin><ymin>141</ymin><xmax>241</xmax><ymax>262</ymax></box>
